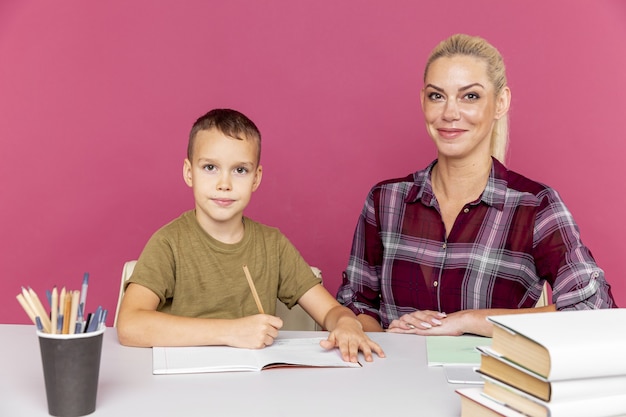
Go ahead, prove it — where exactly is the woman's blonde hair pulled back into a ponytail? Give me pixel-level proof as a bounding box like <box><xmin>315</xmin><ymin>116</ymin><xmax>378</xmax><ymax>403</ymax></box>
<box><xmin>424</xmin><ymin>34</ymin><xmax>509</xmax><ymax>164</ymax></box>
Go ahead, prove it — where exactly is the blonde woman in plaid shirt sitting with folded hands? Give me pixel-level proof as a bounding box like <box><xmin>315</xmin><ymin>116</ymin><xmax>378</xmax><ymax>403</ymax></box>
<box><xmin>337</xmin><ymin>34</ymin><xmax>615</xmax><ymax>336</ymax></box>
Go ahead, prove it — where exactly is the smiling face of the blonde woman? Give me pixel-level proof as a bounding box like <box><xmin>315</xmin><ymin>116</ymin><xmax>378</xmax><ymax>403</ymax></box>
<box><xmin>421</xmin><ymin>55</ymin><xmax>510</xmax><ymax>159</ymax></box>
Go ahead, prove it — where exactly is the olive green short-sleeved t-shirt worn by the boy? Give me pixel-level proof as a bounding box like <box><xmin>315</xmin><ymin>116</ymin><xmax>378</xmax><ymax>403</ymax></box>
<box><xmin>126</xmin><ymin>210</ymin><xmax>321</xmax><ymax>319</ymax></box>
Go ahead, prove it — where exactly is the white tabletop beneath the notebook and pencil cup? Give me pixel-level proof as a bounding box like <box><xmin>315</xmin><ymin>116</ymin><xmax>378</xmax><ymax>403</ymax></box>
<box><xmin>0</xmin><ymin>324</ymin><xmax>460</xmax><ymax>417</ymax></box>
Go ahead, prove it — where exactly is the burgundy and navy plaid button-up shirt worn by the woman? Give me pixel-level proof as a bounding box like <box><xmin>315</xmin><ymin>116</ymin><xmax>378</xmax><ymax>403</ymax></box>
<box><xmin>337</xmin><ymin>159</ymin><xmax>615</xmax><ymax>328</ymax></box>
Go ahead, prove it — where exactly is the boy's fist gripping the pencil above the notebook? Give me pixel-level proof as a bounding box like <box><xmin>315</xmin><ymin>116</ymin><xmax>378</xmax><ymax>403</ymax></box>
<box><xmin>228</xmin><ymin>314</ymin><xmax>283</xmax><ymax>349</ymax></box>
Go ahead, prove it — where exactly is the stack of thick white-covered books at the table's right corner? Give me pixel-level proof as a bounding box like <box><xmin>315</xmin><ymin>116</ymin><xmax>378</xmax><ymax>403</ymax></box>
<box><xmin>457</xmin><ymin>309</ymin><xmax>626</xmax><ymax>417</ymax></box>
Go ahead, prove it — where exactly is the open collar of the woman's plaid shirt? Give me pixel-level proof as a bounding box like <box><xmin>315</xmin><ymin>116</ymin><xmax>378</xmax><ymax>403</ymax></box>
<box><xmin>404</xmin><ymin>157</ymin><xmax>508</xmax><ymax>210</ymax></box>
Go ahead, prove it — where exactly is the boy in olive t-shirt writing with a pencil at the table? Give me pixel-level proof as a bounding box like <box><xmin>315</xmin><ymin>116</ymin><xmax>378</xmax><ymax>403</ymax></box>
<box><xmin>117</xmin><ymin>109</ymin><xmax>384</xmax><ymax>362</ymax></box>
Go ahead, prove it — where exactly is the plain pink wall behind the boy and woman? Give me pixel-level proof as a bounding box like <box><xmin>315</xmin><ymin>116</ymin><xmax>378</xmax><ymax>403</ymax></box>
<box><xmin>0</xmin><ymin>0</ymin><xmax>626</xmax><ymax>324</ymax></box>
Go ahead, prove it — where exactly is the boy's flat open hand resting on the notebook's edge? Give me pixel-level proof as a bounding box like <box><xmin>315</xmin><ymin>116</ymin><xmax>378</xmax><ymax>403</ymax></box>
<box><xmin>320</xmin><ymin>317</ymin><xmax>385</xmax><ymax>362</ymax></box>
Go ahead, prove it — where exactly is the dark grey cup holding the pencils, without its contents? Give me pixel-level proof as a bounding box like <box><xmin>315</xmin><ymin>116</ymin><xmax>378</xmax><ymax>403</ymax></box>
<box><xmin>37</xmin><ymin>328</ymin><xmax>105</xmax><ymax>417</ymax></box>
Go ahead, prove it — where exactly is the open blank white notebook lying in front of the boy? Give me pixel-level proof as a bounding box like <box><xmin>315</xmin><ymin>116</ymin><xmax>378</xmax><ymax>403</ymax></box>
<box><xmin>152</xmin><ymin>337</ymin><xmax>361</xmax><ymax>375</ymax></box>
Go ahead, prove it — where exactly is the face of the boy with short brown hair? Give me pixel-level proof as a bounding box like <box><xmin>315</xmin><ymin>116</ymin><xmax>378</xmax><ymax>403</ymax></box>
<box><xmin>183</xmin><ymin>129</ymin><xmax>262</xmax><ymax>234</ymax></box>
